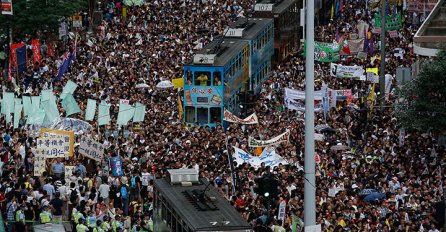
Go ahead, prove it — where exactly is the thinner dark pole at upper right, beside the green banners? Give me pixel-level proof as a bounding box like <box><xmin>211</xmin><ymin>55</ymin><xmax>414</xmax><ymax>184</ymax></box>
<box><xmin>379</xmin><ymin>0</ymin><xmax>386</xmax><ymax>105</ymax></box>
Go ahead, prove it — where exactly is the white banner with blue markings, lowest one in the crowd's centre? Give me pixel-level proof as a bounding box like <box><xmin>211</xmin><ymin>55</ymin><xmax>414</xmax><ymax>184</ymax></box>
<box><xmin>233</xmin><ymin>147</ymin><xmax>288</xmax><ymax>169</ymax></box>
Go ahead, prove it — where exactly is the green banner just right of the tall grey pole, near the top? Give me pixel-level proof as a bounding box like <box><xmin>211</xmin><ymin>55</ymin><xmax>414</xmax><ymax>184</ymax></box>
<box><xmin>303</xmin><ymin>41</ymin><xmax>342</xmax><ymax>63</ymax></box>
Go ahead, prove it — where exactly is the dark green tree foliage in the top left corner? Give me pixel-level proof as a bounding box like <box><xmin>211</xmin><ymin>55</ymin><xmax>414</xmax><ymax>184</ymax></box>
<box><xmin>0</xmin><ymin>0</ymin><xmax>88</xmax><ymax>36</ymax></box>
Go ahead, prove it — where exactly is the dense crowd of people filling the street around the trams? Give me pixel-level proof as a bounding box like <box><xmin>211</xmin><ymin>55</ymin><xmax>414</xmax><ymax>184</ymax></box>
<box><xmin>0</xmin><ymin>0</ymin><xmax>446</xmax><ymax>232</ymax></box>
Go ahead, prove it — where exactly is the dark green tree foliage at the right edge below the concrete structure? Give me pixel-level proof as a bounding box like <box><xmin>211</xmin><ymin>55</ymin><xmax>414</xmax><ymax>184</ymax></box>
<box><xmin>396</xmin><ymin>50</ymin><xmax>446</xmax><ymax>132</ymax></box>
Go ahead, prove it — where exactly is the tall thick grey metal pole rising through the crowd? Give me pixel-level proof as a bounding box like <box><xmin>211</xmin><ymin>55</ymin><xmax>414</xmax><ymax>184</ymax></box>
<box><xmin>304</xmin><ymin>0</ymin><xmax>316</xmax><ymax>226</ymax></box>
